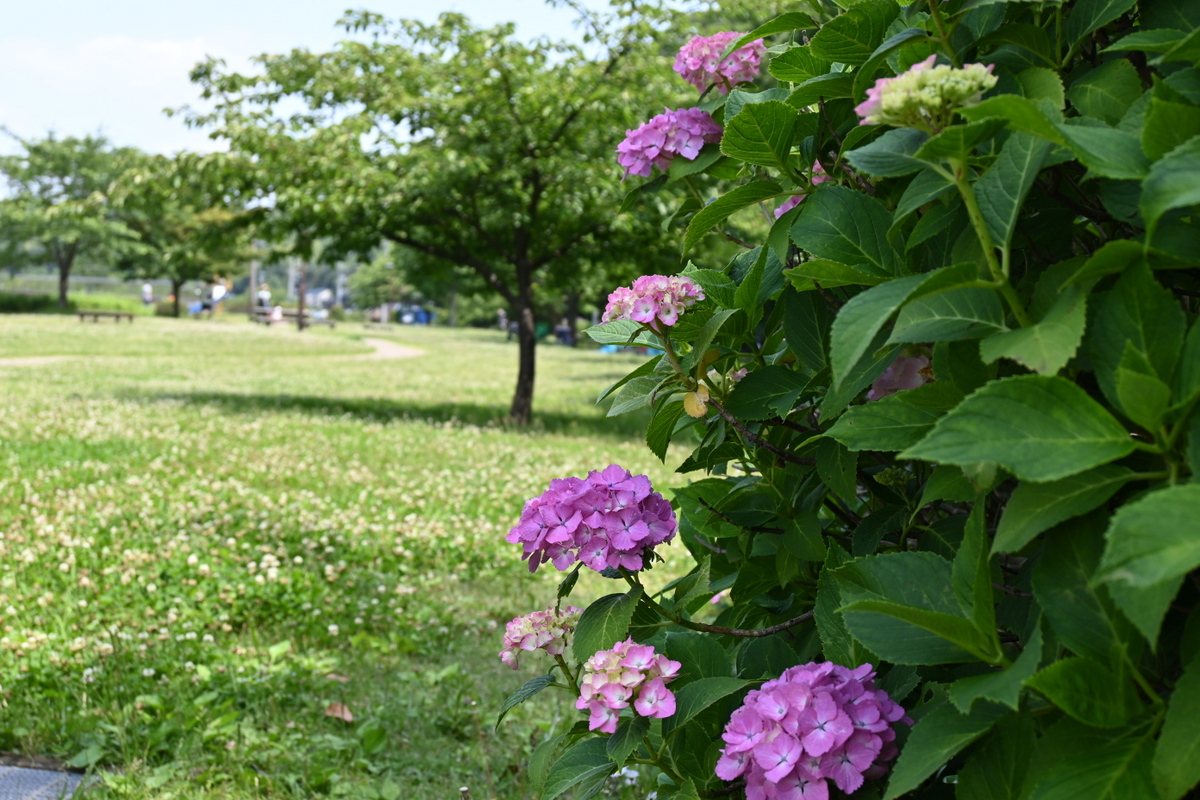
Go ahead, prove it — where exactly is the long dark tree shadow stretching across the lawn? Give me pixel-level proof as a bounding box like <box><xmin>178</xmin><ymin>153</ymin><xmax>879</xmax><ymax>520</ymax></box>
<box><xmin>135</xmin><ymin>392</ymin><xmax>649</xmax><ymax>440</ymax></box>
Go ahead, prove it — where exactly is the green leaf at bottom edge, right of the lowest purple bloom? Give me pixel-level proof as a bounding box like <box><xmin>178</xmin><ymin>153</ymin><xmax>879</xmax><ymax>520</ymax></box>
<box><xmin>883</xmin><ymin>703</ymin><xmax>1008</xmax><ymax>800</ymax></box>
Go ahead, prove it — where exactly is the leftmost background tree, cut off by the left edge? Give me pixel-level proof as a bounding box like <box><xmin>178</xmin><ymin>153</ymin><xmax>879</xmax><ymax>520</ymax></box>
<box><xmin>0</xmin><ymin>133</ymin><xmax>140</xmax><ymax>308</ymax></box>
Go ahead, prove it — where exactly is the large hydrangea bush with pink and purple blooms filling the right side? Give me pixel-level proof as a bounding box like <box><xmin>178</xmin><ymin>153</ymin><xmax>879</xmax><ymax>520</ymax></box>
<box><xmin>494</xmin><ymin>0</ymin><xmax>1200</xmax><ymax>800</ymax></box>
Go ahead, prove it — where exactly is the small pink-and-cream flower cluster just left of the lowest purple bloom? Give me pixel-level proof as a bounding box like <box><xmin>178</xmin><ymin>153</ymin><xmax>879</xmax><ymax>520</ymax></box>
<box><xmin>575</xmin><ymin>639</ymin><xmax>679</xmax><ymax>733</ymax></box>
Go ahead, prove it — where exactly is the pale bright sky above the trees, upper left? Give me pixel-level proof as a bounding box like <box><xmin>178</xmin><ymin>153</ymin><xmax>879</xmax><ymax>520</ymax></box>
<box><xmin>0</xmin><ymin>0</ymin><xmax>602</xmax><ymax>154</ymax></box>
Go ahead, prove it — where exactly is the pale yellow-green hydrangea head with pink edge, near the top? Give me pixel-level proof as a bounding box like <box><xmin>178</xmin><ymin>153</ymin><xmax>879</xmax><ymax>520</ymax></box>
<box><xmin>854</xmin><ymin>55</ymin><xmax>996</xmax><ymax>133</ymax></box>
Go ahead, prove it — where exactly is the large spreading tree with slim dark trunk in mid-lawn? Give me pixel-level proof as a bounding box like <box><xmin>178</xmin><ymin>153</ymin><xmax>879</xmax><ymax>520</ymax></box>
<box><xmin>182</xmin><ymin>13</ymin><xmax>673</xmax><ymax>423</ymax></box>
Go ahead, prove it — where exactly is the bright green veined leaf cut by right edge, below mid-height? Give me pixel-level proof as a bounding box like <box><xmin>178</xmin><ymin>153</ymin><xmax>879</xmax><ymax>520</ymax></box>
<box><xmin>1097</xmin><ymin>483</ymin><xmax>1200</xmax><ymax>587</ymax></box>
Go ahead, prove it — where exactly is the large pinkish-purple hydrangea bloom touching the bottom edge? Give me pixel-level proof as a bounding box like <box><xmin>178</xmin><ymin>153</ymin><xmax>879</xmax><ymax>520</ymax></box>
<box><xmin>716</xmin><ymin>661</ymin><xmax>912</xmax><ymax>800</ymax></box>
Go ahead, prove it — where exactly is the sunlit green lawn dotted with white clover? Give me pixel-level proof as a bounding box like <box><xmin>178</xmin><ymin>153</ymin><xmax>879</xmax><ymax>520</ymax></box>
<box><xmin>0</xmin><ymin>317</ymin><xmax>683</xmax><ymax>800</ymax></box>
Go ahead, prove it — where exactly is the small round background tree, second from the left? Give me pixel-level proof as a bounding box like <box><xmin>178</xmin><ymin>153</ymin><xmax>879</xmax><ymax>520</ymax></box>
<box><xmin>113</xmin><ymin>152</ymin><xmax>262</xmax><ymax>317</ymax></box>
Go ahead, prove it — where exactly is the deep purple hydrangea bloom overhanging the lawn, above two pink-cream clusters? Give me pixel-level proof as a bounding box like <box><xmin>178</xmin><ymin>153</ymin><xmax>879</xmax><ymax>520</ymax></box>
<box><xmin>506</xmin><ymin>464</ymin><xmax>678</xmax><ymax>572</ymax></box>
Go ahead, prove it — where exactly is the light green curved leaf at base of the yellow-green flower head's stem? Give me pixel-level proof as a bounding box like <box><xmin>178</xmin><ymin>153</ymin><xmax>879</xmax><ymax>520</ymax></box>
<box><xmin>979</xmin><ymin>285</ymin><xmax>1087</xmax><ymax>375</ymax></box>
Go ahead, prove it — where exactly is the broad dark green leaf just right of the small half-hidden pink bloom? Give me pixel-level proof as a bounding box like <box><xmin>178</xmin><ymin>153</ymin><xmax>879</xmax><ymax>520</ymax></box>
<box><xmin>791</xmin><ymin>185</ymin><xmax>900</xmax><ymax>275</ymax></box>
